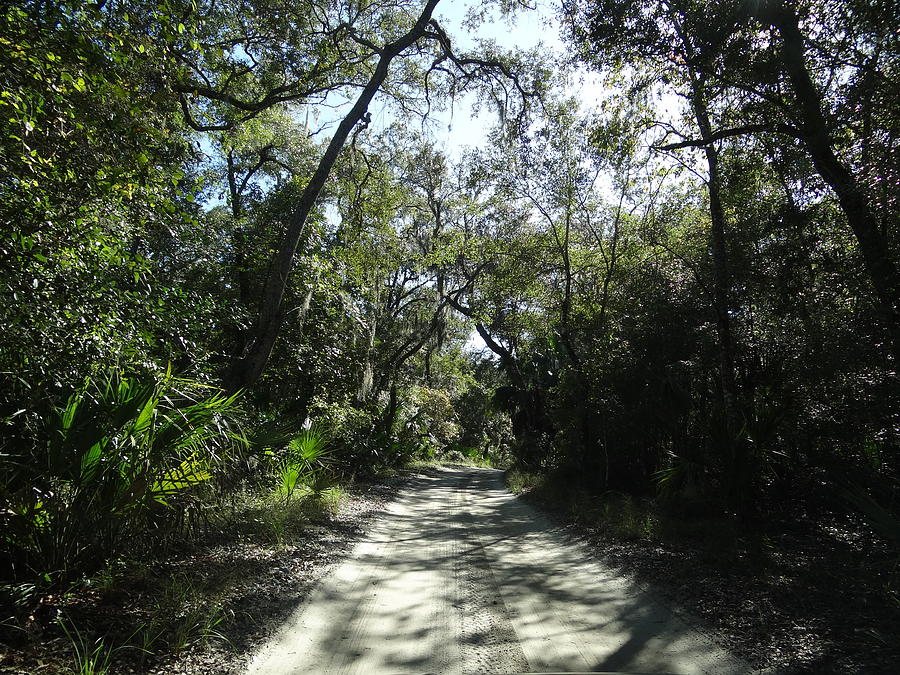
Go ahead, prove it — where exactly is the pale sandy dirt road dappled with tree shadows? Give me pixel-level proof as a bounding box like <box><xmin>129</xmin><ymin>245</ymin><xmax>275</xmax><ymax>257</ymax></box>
<box><xmin>248</xmin><ymin>469</ymin><xmax>750</xmax><ymax>675</ymax></box>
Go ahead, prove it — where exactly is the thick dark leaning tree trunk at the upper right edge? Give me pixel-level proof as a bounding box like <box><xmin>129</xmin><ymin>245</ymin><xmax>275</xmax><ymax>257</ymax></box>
<box><xmin>757</xmin><ymin>1</ymin><xmax>900</xmax><ymax>364</ymax></box>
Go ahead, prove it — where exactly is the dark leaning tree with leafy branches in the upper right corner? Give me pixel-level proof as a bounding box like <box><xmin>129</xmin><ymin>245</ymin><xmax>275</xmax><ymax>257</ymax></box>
<box><xmin>566</xmin><ymin>0</ymin><xmax>900</xmax><ymax>360</ymax></box>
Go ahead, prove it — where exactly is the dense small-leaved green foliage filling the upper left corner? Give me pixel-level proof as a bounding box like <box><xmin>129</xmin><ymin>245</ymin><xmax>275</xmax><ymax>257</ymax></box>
<box><xmin>0</xmin><ymin>2</ymin><xmax>206</xmax><ymax>396</ymax></box>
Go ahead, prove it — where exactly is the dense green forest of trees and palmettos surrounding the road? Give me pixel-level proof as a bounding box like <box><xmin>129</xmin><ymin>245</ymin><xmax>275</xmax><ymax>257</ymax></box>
<box><xmin>0</xmin><ymin>0</ymin><xmax>900</xmax><ymax>672</ymax></box>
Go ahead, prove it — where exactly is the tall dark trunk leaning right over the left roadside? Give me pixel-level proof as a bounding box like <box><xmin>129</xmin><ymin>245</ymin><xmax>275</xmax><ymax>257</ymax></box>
<box><xmin>223</xmin><ymin>0</ymin><xmax>439</xmax><ymax>392</ymax></box>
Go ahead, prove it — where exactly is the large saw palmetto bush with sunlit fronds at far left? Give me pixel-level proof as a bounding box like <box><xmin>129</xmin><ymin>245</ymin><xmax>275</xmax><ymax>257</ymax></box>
<box><xmin>0</xmin><ymin>372</ymin><xmax>245</xmax><ymax>578</ymax></box>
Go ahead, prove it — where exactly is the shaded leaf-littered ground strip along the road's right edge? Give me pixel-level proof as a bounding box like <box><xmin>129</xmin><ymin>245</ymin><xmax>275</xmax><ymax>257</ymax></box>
<box><xmin>506</xmin><ymin>469</ymin><xmax>900</xmax><ymax>673</ymax></box>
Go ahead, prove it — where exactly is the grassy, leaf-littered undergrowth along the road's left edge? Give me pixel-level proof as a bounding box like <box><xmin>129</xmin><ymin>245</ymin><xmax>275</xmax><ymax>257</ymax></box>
<box><xmin>0</xmin><ymin>484</ymin><xmax>348</xmax><ymax>675</ymax></box>
